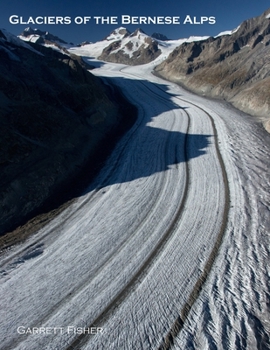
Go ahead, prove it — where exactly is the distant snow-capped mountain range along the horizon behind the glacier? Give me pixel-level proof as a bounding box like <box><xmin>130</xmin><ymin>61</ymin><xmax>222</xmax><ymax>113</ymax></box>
<box><xmin>18</xmin><ymin>27</ymin><xmax>208</xmax><ymax>66</ymax></box>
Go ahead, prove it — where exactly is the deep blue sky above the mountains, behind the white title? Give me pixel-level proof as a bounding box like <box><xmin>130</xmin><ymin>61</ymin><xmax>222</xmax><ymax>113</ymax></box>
<box><xmin>0</xmin><ymin>0</ymin><xmax>270</xmax><ymax>44</ymax></box>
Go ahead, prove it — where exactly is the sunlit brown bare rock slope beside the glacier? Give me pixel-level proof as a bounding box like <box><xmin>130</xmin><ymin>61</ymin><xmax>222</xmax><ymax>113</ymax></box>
<box><xmin>155</xmin><ymin>10</ymin><xmax>270</xmax><ymax>130</ymax></box>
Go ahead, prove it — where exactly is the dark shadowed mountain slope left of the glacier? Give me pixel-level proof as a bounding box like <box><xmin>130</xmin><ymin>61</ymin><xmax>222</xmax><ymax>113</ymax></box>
<box><xmin>0</xmin><ymin>30</ymin><xmax>134</xmax><ymax>234</ymax></box>
